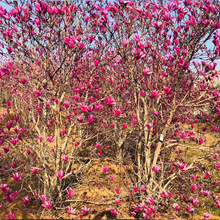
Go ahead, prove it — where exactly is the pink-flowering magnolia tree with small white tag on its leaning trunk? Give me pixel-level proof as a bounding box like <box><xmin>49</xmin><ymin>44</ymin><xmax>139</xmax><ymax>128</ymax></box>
<box><xmin>99</xmin><ymin>1</ymin><xmax>219</xmax><ymax>190</ymax></box>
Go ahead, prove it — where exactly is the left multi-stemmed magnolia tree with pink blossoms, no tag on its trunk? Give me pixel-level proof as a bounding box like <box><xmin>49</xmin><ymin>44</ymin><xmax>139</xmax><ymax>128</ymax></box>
<box><xmin>1</xmin><ymin>2</ymin><xmax>115</xmax><ymax>200</ymax></box>
